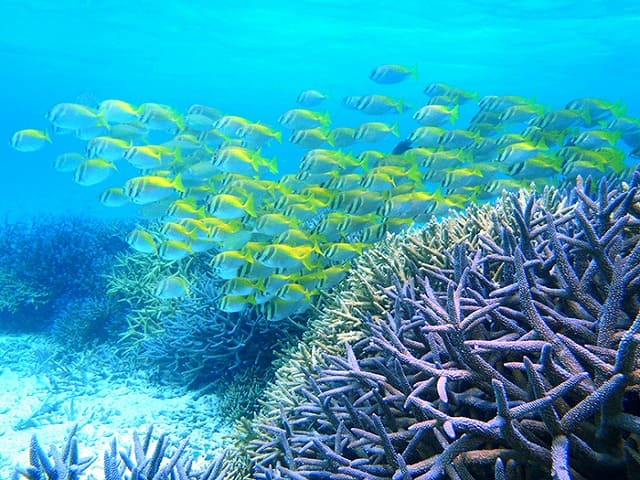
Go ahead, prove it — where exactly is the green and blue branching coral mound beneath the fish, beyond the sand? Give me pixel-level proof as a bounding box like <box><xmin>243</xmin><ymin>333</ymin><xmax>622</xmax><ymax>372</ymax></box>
<box><xmin>107</xmin><ymin>238</ymin><xmax>302</xmax><ymax>389</ymax></box>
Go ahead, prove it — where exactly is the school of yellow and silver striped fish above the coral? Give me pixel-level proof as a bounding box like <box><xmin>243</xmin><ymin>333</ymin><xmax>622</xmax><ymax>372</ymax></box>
<box><xmin>10</xmin><ymin>65</ymin><xmax>640</xmax><ymax>321</ymax></box>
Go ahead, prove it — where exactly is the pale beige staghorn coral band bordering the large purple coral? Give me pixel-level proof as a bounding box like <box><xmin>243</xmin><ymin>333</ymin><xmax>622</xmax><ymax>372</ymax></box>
<box><xmin>233</xmin><ymin>189</ymin><xmax>565</xmax><ymax>472</ymax></box>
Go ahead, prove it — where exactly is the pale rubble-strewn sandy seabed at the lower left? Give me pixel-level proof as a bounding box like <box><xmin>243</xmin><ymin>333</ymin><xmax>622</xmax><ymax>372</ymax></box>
<box><xmin>0</xmin><ymin>335</ymin><xmax>231</xmax><ymax>479</ymax></box>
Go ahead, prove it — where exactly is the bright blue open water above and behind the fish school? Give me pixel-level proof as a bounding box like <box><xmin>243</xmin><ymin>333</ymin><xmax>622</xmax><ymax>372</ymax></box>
<box><xmin>0</xmin><ymin>0</ymin><xmax>640</xmax><ymax>218</ymax></box>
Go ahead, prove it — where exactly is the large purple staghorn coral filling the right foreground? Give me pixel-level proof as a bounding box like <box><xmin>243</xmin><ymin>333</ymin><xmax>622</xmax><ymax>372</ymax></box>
<box><xmin>249</xmin><ymin>172</ymin><xmax>640</xmax><ymax>480</ymax></box>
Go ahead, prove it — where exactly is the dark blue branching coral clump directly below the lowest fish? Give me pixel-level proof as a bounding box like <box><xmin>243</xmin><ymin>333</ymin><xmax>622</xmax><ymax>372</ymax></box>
<box><xmin>140</xmin><ymin>275</ymin><xmax>300</xmax><ymax>388</ymax></box>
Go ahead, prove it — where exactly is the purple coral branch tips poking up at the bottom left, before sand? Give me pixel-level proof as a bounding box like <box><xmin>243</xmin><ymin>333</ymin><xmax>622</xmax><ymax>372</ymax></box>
<box><xmin>13</xmin><ymin>427</ymin><xmax>226</xmax><ymax>480</ymax></box>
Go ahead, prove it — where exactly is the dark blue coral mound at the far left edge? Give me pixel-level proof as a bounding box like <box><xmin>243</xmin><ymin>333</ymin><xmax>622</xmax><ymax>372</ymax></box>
<box><xmin>0</xmin><ymin>216</ymin><xmax>128</xmax><ymax>331</ymax></box>
